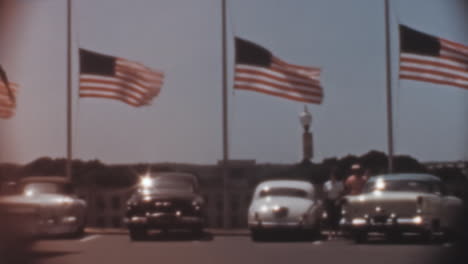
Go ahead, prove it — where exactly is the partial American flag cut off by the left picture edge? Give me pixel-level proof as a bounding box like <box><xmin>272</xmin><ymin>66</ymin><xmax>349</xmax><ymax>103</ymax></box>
<box><xmin>0</xmin><ymin>66</ymin><xmax>18</xmax><ymax>119</ymax></box>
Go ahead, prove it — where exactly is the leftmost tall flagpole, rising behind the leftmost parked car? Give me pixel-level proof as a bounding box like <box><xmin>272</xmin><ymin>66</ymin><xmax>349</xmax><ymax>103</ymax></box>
<box><xmin>65</xmin><ymin>0</ymin><xmax>72</xmax><ymax>181</ymax></box>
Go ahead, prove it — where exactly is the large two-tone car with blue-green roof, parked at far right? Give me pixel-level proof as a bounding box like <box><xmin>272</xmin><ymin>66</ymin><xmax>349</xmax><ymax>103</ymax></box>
<box><xmin>340</xmin><ymin>173</ymin><xmax>463</xmax><ymax>242</ymax></box>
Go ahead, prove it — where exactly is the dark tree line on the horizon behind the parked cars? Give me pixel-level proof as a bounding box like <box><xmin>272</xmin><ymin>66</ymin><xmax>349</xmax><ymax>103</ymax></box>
<box><xmin>0</xmin><ymin>150</ymin><xmax>467</xmax><ymax>198</ymax></box>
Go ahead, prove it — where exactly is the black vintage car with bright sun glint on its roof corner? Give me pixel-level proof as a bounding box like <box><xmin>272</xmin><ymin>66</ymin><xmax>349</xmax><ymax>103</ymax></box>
<box><xmin>124</xmin><ymin>172</ymin><xmax>204</xmax><ymax>240</ymax></box>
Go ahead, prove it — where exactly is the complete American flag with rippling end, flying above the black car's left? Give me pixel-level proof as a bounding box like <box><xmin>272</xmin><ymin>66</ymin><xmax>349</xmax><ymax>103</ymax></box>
<box><xmin>80</xmin><ymin>49</ymin><xmax>164</xmax><ymax>107</ymax></box>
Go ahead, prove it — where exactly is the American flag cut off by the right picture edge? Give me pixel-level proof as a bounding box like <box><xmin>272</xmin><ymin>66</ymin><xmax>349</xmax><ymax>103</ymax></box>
<box><xmin>400</xmin><ymin>25</ymin><xmax>468</xmax><ymax>89</ymax></box>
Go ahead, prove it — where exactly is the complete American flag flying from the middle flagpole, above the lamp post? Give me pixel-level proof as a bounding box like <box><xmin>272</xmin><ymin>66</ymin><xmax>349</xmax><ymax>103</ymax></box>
<box><xmin>234</xmin><ymin>38</ymin><xmax>323</xmax><ymax>104</ymax></box>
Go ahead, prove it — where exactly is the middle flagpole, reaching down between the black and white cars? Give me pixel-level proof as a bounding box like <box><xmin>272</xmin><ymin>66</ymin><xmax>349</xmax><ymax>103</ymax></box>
<box><xmin>221</xmin><ymin>0</ymin><xmax>229</xmax><ymax>228</ymax></box>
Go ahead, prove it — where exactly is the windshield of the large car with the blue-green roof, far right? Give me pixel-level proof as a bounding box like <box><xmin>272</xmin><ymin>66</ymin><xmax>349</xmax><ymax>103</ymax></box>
<box><xmin>364</xmin><ymin>179</ymin><xmax>440</xmax><ymax>193</ymax></box>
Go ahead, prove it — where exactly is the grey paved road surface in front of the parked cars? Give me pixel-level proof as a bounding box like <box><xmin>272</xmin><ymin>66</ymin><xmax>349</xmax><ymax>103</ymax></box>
<box><xmin>3</xmin><ymin>234</ymin><xmax>458</xmax><ymax>264</ymax></box>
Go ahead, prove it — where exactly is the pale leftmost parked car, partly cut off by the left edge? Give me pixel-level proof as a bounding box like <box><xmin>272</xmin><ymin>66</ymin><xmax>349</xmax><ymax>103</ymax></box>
<box><xmin>0</xmin><ymin>176</ymin><xmax>86</xmax><ymax>238</ymax></box>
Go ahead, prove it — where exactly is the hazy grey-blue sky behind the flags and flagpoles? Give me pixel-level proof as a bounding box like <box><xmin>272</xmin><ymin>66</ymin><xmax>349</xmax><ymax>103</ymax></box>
<box><xmin>0</xmin><ymin>0</ymin><xmax>468</xmax><ymax>163</ymax></box>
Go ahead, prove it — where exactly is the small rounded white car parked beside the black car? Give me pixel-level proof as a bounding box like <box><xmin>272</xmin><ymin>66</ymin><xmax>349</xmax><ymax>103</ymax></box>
<box><xmin>247</xmin><ymin>180</ymin><xmax>323</xmax><ymax>241</ymax></box>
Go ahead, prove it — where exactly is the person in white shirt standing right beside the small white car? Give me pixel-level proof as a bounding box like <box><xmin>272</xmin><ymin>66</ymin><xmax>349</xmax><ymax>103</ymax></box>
<box><xmin>323</xmin><ymin>171</ymin><xmax>344</xmax><ymax>239</ymax></box>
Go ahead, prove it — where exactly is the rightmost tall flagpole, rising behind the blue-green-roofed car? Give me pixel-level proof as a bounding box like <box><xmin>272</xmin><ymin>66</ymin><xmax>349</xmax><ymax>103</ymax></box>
<box><xmin>384</xmin><ymin>0</ymin><xmax>393</xmax><ymax>173</ymax></box>
